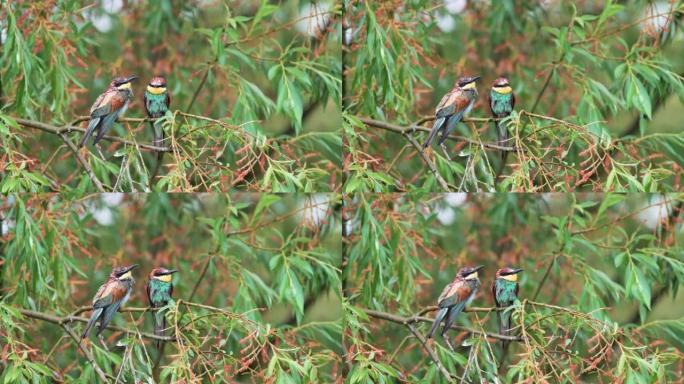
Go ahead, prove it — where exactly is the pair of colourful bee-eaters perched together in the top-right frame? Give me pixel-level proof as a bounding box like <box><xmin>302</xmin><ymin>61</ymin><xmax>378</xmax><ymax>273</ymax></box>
<box><xmin>423</xmin><ymin>76</ymin><xmax>515</xmax><ymax>160</ymax></box>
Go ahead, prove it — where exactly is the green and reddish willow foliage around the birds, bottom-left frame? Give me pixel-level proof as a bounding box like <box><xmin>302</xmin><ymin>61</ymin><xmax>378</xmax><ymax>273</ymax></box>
<box><xmin>0</xmin><ymin>194</ymin><xmax>341</xmax><ymax>383</ymax></box>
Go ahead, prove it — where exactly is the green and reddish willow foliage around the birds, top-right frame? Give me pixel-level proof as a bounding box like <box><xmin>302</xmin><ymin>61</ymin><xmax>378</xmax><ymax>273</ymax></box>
<box><xmin>344</xmin><ymin>0</ymin><xmax>684</xmax><ymax>192</ymax></box>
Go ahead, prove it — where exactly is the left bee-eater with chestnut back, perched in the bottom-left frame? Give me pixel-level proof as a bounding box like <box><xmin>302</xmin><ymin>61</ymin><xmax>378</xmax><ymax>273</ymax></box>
<box><xmin>81</xmin><ymin>264</ymin><xmax>138</xmax><ymax>339</ymax></box>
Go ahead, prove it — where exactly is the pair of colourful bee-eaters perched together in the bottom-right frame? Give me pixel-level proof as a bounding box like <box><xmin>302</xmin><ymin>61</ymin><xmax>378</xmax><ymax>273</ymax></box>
<box><xmin>427</xmin><ymin>265</ymin><xmax>522</xmax><ymax>350</ymax></box>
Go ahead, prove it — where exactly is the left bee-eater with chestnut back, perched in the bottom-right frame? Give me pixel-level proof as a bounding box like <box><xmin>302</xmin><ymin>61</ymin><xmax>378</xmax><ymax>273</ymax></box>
<box><xmin>428</xmin><ymin>265</ymin><xmax>484</xmax><ymax>350</ymax></box>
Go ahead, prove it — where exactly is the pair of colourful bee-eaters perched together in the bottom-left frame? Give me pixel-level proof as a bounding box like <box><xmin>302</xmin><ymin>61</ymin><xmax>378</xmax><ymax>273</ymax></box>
<box><xmin>81</xmin><ymin>264</ymin><xmax>178</xmax><ymax>346</ymax></box>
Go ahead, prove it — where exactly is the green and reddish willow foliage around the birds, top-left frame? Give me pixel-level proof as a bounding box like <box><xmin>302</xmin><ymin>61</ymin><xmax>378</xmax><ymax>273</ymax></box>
<box><xmin>0</xmin><ymin>0</ymin><xmax>342</xmax><ymax>193</ymax></box>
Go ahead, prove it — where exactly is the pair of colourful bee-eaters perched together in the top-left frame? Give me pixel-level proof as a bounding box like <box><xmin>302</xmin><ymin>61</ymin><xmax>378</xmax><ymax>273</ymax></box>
<box><xmin>79</xmin><ymin>76</ymin><xmax>171</xmax><ymax>153</ymax></box>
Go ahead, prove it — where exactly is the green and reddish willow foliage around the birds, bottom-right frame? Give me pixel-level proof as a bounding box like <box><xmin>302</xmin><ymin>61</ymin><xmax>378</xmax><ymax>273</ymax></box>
<box><xmin>343</xmin><ymin>193</ymin><xmax>684</xmax><ymax>383</ymax></box>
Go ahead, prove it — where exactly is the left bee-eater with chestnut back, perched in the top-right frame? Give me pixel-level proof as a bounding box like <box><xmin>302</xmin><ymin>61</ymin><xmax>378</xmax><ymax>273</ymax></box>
<box><xmin>423</xmin><ymin>76</ymin><xmax>480</xmax><ymax>160</ymax></box>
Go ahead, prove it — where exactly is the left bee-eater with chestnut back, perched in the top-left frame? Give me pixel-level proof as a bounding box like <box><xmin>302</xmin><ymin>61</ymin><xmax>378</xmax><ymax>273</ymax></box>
<box><xmin>78</xmin><ymin>76</ymin><xmax>138</xmax><ymax>147</ymax></box>
